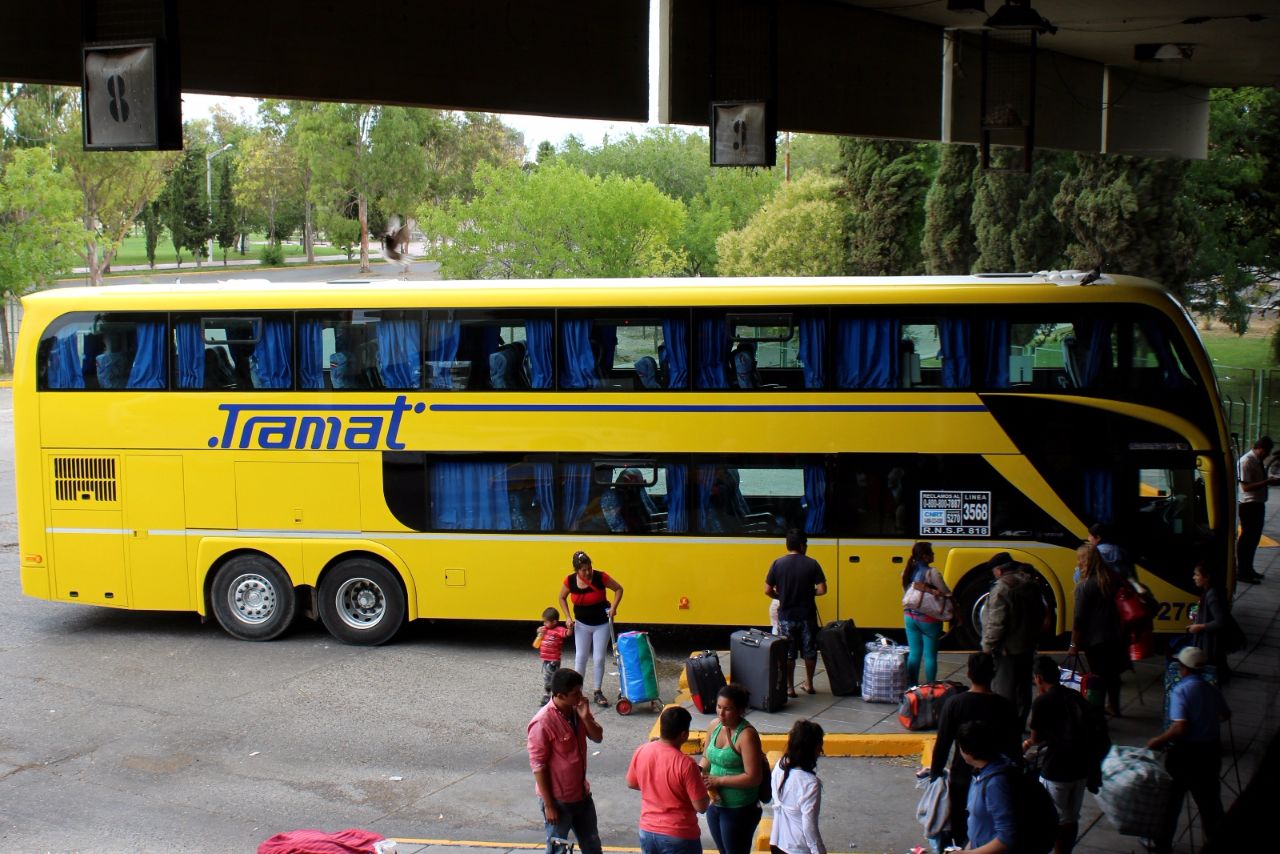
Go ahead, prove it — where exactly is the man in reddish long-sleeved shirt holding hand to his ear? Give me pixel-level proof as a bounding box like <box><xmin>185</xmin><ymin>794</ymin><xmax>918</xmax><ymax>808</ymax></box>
<box><xmin>529</xmin><ymin>667</ymin><xmax>604</xmax><ymax>854</ymax></box>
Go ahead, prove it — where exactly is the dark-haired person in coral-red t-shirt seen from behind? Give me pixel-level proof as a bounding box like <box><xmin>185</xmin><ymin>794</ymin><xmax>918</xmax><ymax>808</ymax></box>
<box><xmin>627</xmin><ymin>705</ymin><xmax>710</xmax><ymax>854</ymax></box>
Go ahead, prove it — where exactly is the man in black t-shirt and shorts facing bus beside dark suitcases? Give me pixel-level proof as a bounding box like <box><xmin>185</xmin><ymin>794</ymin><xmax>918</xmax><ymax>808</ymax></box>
<box><xmin>764</xmin><ymin>528</ymin><xmax>827</xmax><ymax>697</ymax></box>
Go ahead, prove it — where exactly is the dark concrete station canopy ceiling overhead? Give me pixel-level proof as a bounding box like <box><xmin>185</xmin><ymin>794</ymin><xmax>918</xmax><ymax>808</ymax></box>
<box><xmin>0</xmin><ymin>0</ymin><xmax>1280</xmax><ymax>156</ymax></box>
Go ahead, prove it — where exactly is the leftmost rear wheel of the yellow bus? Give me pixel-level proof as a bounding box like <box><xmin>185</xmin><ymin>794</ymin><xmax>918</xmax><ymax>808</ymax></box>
<box><xmin>210</xmin><ymin>554</ymin><xmax>298</xmax><ymax>640</ymax></box>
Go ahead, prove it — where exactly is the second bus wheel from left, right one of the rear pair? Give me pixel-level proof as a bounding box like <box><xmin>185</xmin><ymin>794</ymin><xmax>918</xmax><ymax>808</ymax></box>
<box><xmin>319</xmin><ymin>557</ymin><xmax>406</xmax><ymax>647</ymax></box>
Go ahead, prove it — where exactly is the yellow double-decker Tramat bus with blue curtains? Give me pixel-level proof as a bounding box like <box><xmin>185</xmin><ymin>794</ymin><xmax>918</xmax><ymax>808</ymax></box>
<box><xmin>14</xmin><ymin>274</ymin><xmax>1234</xmax><ymax>644</ymax></box>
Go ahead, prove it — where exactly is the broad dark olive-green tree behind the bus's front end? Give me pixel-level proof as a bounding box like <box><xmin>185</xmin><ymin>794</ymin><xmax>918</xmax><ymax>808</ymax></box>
<box><xmin>1053</xmin><ymin>154</ymin><xmax>1198</xmax><ymax>296</ymax></box>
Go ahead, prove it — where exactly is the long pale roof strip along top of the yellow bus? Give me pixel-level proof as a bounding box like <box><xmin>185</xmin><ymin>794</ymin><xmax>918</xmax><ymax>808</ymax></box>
<box><xmin>23</xmin><ymin>271</ymin><xmax>1165</xmax><ymax>312</ymax></box>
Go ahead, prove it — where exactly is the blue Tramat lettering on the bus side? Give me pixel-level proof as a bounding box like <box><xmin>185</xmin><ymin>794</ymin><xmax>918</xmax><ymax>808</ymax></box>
<box><xmin>209</xmin><ymin>394</ymin><xmax>426</xmax><ymax>451</ymax></box>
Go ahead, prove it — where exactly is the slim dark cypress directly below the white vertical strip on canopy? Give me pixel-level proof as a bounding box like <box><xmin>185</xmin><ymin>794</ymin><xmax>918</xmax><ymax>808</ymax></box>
<box><xmin>920</xmin><ymin>145</ymin><xmax>978</xmax><ymax>275</ymax></box>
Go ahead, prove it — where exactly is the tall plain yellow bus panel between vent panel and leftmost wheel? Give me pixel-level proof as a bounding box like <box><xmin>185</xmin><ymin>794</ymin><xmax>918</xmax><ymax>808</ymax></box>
<box><xmin>124</xmin><ymin>455</ymin><xmax>192</xmax><ymax>611</ymax></box>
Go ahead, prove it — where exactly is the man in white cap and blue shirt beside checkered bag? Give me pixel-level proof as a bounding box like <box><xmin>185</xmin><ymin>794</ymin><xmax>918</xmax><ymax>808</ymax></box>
<box><xmin>1147</xmin><ymin>647</ymin><xmax>1231</xmax><ymax>854</ymax></box>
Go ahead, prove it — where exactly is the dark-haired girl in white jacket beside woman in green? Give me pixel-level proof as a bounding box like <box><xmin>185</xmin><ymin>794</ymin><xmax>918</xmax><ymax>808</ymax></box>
<box><xmin>769</xmin><ymin>720</ymin><xmax>827</xmax><ymax>854</ymax></box>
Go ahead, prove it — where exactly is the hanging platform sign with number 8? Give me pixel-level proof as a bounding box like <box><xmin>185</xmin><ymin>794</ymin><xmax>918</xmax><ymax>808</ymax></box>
<box><xmin>82</xmin><ymin>41</ymin><xmax>160</xmax><ymax>151</ymax></box>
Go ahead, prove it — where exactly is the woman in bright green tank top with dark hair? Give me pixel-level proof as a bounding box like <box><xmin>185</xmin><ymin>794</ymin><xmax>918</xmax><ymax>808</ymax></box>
<box><xmin>703</xmin><ymin>685</ymin><xmax>764</xmax><ymax>854</ymax></box>
